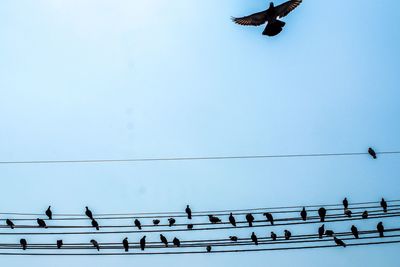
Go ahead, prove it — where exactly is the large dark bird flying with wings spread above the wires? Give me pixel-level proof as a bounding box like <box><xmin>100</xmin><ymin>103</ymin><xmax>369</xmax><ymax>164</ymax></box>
<box><xmin>232</xmin><ymin>0</ymin><xmax>302</xmax><ymax>36</ymax></box>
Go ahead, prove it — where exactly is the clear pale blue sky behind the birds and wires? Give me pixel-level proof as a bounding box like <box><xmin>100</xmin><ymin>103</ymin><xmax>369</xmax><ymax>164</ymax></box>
<box><xmin>0</xmin><ymin>0</ymin><xmax>400</xmax><ymax>267</ymax></box>
